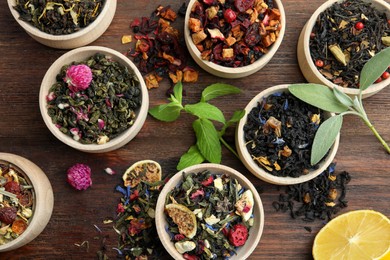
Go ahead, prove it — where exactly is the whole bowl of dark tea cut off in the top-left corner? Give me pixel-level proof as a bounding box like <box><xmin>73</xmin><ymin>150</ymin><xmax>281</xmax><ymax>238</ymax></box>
<box><xmin>8</xmin><ymin>0</ymin><xmax>117</xmax><ymax>49</ymax></box>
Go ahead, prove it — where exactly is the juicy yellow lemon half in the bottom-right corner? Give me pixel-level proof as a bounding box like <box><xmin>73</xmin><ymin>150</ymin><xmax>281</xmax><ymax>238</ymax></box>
<box><xmin>313</xmin><ymin>210</ymin><xmax>390</xmax><ymax>260</ymax></box>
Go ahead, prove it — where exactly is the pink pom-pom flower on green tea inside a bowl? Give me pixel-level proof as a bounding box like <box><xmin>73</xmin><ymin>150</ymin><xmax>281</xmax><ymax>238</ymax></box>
<box><xmin>64</xmin><ymin>64</ymin><xmax>92</xmax><ymax>92</ymax></box>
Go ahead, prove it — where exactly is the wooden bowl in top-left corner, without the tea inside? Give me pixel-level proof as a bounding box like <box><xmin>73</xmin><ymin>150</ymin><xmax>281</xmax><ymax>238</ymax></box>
<box><xmin>7</xmin><ymin>0</ymin><xmax>117</xmax><ymax>49</ymax></box>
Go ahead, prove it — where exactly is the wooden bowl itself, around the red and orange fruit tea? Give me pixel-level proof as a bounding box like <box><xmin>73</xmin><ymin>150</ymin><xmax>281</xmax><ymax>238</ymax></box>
<box><xmin>184</xmin><ymin>0</ymin><xmax>286</xmax><ymax>78</ymax></box>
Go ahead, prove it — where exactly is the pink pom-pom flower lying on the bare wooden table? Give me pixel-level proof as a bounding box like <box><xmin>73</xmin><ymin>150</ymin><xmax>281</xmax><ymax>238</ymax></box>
<box><xmin>67</xmin><ymin>163</ymin><xmax>92</xmax><ymax>190</ymax></box>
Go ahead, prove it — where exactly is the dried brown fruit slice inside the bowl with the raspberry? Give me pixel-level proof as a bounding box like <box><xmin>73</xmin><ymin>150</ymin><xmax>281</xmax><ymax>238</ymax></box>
<box><xmin>165</xmin><ymin>203</ymin><xmax>197</xmax><ymax>238</ymax></box>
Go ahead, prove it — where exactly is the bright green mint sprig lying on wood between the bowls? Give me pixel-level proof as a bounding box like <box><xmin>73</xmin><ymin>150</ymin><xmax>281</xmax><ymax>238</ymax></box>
<box><xmin>149</xmin><ymin>82</ymin><xmax>245</xmax><ymax>170</ymax></box>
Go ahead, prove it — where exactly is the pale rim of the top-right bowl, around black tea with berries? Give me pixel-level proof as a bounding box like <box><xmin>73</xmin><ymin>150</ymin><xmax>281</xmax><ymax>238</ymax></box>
<box><xmin>302</xmin><ymin>0</ymin><xmax>390</xmax><ymax>96</ymax></box>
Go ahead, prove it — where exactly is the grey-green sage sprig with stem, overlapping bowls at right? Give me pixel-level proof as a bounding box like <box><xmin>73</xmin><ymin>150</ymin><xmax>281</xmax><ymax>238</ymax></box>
<box><xmin>288</xmin><ymin>47</ymin><xmax>390</xmax><ymax>165</ymax></box>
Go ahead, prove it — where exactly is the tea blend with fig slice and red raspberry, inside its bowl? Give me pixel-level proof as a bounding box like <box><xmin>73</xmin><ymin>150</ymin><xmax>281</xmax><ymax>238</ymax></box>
<box><xmin>165</xmin><ymin>170</ymin><xmax>255</xmax><ymax>259</ymax></box>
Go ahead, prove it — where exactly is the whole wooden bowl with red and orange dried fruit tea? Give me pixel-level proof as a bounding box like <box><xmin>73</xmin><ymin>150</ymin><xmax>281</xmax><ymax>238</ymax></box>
<box><xmin>184</xmin><ymin>0</ymin><xmax>286</xmax><ymax>78</ymax></box>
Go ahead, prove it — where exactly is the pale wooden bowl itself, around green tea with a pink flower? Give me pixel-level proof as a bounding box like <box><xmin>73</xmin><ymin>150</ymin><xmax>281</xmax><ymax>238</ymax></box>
<box><xmin>39</xmin><ymin>46</ymin><xmax>149</xmax><ymax>153</ymax></box>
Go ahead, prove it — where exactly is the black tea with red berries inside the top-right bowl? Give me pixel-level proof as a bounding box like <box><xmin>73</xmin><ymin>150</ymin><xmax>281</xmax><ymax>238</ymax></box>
<box><xmin>309</xmin><ymin>0</ymin><xmax>390</xmax><ymax>88</ymax></box>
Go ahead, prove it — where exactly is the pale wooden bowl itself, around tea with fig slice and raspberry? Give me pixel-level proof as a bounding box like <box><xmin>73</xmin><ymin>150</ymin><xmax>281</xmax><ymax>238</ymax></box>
<box><xmin>156</xmin><ymin>163</ymin><xmax>264</xmax><ymax>260</ymax></box>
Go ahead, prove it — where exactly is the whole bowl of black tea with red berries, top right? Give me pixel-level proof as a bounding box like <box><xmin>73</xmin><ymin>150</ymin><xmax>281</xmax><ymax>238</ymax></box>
<box><xmin>297</xmin><ymin>0</ymin><xmax>390</xmax><ymax>98</ymax></box>
